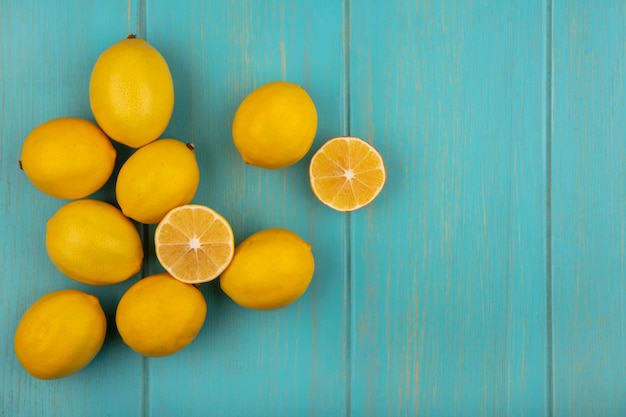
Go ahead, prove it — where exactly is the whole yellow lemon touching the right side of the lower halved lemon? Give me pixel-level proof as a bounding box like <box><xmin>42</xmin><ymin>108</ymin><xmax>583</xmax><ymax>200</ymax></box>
<box><xmin>220</xmin><ymin>229</ymin><xmax>315</xmax><ymax>310</ymax></box>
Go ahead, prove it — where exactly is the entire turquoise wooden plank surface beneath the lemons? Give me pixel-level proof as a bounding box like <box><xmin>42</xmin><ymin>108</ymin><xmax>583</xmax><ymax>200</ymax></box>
<box><xmin>0</xmin><ymin>0</ymin><xmax>626</xmax><ymax>417</ymax></box>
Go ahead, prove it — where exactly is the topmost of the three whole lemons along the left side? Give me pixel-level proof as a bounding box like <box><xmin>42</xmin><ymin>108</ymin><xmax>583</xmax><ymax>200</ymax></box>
<box><xmin>20</xmin><ymin>117</ymin><xmax>116</xmax><ymax>199</ymax></box>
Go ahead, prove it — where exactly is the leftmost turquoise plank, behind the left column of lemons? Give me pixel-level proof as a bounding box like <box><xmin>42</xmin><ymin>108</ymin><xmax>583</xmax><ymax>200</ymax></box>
<box><xmin>0</xmin><ymin>0</ymin><xmax>142</xmax><ymax>416</ymax></box>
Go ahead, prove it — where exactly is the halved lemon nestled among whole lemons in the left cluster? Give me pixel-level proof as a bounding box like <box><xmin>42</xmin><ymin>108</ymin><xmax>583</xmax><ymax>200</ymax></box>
<box><xmin>154</xmin><ymin>204</ymin><xmax>235</xmax><ymax>284</ymax></box>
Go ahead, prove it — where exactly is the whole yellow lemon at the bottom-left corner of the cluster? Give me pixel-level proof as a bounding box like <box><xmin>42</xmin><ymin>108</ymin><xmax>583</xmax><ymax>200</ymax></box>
<box><xmin>13</xmin><ymin>290</ymin><xmax>107</xmax><ymax>379</ymax></box>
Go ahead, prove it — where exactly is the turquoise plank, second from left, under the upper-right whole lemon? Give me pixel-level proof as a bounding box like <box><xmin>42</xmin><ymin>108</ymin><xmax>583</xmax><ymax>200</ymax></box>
<box><xmin>146</xmin><ymin>0</ymin><xmax>347</xmax><ymax>416</ymax></box>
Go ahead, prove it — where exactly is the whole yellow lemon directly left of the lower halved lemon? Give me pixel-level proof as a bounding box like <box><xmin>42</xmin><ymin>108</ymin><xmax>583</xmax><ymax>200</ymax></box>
<box><xmin>46</xmin><ymin>199</ymin><xmax>143</xmax><ymax>285</ymax></box>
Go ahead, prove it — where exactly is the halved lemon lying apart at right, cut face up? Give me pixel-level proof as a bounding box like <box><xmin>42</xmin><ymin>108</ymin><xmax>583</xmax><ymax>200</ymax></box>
<box><xmin>309</xmin><ymin>136</ymin><xmax>386</xmax><ymax>211</ymax></box>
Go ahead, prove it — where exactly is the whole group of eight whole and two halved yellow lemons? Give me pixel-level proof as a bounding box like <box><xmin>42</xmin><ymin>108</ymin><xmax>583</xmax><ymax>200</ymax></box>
<box><xmin>14</xmin><ymin>35</ymin><xmax>385</xmax><ymax>379</ymax></box>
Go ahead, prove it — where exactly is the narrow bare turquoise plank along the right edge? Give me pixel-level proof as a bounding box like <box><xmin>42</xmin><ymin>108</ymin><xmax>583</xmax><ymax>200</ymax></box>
<box><xmin>552</xmin><ymin>0</ymin><xmax>626</xmax><ymax>417</ymax></box>
